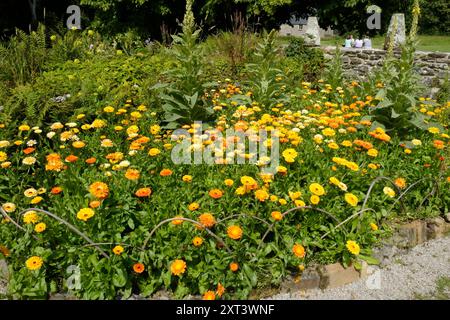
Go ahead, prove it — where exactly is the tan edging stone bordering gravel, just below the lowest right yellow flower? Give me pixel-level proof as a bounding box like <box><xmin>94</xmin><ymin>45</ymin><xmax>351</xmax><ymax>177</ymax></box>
<box><xmin>318</xmin><ymin>263</ymin><xmax>360</xmax><ymax>289</ymax></box>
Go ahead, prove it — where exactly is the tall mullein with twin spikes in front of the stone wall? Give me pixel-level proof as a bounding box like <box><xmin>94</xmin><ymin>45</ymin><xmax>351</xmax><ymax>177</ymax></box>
<box><xmin>371</xmin><ymin>0</ymin><xmax>442</xmax><ymax>137</ymax></box>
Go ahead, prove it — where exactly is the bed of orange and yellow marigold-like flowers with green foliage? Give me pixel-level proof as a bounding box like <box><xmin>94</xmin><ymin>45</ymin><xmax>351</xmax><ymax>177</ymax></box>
<box><xmin>0</xmin><ymin>82</ymin><xmax>450</xmax><ymax>299</ymax></box>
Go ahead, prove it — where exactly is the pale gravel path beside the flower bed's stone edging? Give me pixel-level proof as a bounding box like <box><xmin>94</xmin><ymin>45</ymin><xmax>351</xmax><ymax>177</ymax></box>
<box><xmin>271</xmin><ymin>237</ymin><xmax>450</xmax><ymax>300</ymax></box>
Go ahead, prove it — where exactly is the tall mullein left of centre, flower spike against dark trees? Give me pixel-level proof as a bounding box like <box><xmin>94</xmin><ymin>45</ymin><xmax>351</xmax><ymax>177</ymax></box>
<box><xmin>153</xmin><ymin>0</ymin><xmax>214</xmax><ymax>129</ymax></box>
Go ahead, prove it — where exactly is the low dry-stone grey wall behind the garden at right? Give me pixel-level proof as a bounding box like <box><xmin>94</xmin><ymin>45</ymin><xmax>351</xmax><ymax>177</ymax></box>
<box><xmin>323</xmin><ymin>47</ymin><xmax>450</xmax><ymax>88</ymax></box>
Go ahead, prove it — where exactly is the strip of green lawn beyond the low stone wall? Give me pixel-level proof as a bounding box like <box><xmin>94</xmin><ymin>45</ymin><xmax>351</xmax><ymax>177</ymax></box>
<box><xmin>320</xmin><ymin>35</ymin><xmax>450</xmax><ymax>52</ymax></box>
